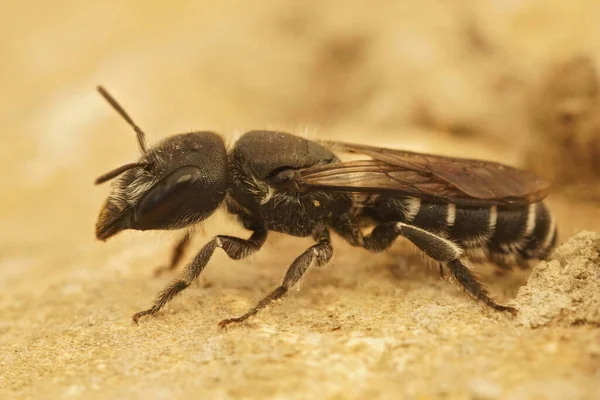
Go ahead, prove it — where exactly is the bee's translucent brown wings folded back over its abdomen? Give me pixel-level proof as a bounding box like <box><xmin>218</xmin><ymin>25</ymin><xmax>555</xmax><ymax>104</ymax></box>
<box><xmin>299</xmin><ymin>142</ymin><xmax>550</xmax><ymax>204</ymax></box>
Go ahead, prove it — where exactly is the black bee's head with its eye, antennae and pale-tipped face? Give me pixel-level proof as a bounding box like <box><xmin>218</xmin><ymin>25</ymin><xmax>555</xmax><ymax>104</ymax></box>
<box><xmin>96</xmin><ymin>87</ymin><xmax>228</xmax><ymax>240</ymax></box>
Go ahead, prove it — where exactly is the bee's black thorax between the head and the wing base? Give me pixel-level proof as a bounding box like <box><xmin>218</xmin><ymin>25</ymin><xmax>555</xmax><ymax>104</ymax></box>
<box><xmin>226</xmin><ymin>131</ymin><xmax>352</xmax><ymax>237</ymax></box>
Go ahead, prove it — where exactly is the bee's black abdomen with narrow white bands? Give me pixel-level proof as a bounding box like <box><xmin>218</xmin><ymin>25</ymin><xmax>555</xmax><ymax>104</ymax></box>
<box><xmin>369</xmin><ymin>197</ymin><xmax>557</xmax><ymax>267</ymax></box>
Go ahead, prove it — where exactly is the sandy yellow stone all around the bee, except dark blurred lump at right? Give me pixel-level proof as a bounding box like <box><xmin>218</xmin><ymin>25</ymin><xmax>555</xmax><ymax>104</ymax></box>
<box><xmin>0</xmin><ymin>0</ymin><xmax>600</xmax><ymax>399</ymax></box>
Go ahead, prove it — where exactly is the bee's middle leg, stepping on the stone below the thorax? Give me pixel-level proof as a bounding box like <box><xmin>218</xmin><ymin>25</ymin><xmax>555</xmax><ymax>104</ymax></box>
<box><xmin>219</xmin><ymin>231</ymin><xmax>333</xmax><ymax>328</ymax></box>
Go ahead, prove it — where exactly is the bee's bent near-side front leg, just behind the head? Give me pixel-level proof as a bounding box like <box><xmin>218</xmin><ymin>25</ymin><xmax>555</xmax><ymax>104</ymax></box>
<box><xmin>132</xmin><ymin>230</ymin><xmax>267</xmax><ymax>323</ymax></box>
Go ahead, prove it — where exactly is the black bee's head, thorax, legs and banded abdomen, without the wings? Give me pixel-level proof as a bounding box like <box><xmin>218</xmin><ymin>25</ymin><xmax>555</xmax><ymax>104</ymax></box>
<box><xmin>92</xmin><ymin>86</ymin><xmax>557</xmax><ymax>326</ymax></box>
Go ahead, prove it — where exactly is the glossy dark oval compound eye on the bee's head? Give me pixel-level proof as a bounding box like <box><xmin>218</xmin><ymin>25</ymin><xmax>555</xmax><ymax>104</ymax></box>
<box><xmin>135</xmin><ymin>167</ymin><xmax>200</xmax><ymax>229</ymax></box>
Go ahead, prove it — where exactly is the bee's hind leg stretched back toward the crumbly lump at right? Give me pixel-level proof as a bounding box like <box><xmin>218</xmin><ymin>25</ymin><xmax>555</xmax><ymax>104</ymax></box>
<box><xmin>356</xmin><ymin>222</ymin><xmax>516</xmax><ymax>313</ymax></box>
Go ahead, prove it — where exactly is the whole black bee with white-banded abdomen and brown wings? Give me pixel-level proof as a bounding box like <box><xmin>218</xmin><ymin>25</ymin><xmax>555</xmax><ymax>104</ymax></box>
<box><xmin>96</xmin><ymin>87</ymin><xmax>557</xmax><ymax>327</ymax></box>
